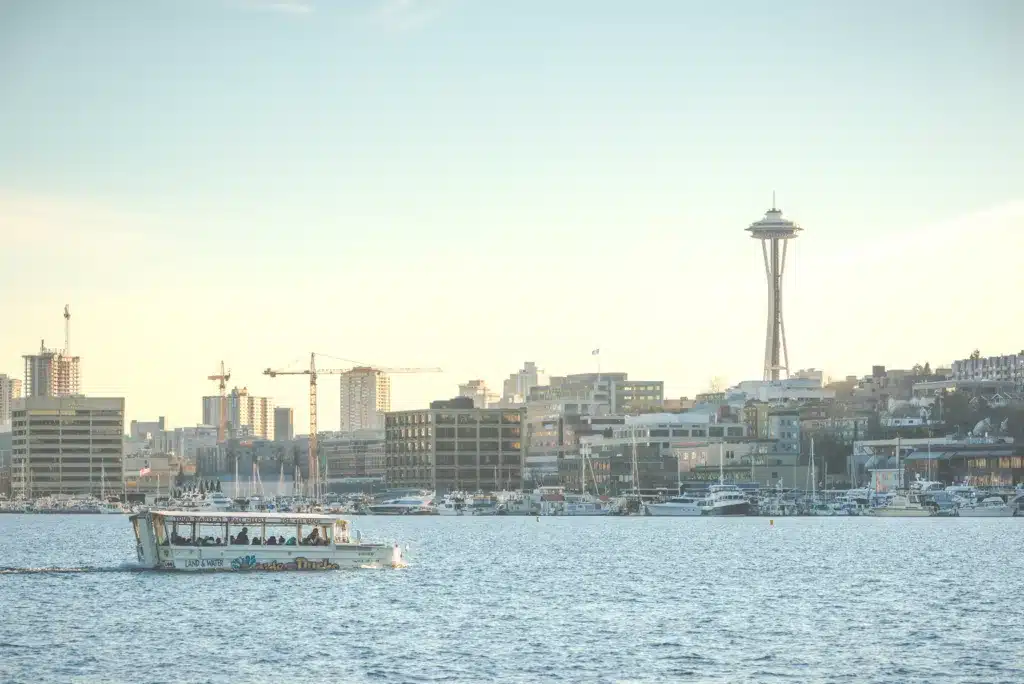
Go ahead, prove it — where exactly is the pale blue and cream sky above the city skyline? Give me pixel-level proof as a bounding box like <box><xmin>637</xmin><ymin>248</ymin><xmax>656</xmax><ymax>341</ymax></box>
<box><xmin>0</xmin><ymin>0</ymin><xmax>1024</xmax><ymax>432</ymax></box>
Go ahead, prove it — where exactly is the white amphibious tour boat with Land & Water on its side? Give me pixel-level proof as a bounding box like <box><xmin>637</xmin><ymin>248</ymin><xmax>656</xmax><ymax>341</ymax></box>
<box><xmin>129</xmin><ymin>511</ymin><xmax>404</xmax><ymax>571</ymax></box>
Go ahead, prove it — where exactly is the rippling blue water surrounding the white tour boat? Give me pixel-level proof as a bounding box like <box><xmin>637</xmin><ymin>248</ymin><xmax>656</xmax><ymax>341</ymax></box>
<box><xmin>0</xmin><ymin>515</ymin><xmax>1024</xmax><ymax>684</ymax></box>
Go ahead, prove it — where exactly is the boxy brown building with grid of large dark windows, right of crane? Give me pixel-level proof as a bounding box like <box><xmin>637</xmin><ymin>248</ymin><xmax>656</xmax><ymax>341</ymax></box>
<box><xmin>384</xmin><ymin>397</ymin><xmax>526</xmax><ymax>494</ymax></box>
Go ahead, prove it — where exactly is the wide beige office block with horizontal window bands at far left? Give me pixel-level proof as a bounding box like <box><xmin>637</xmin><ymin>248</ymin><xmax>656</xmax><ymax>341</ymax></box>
<box><xmin>11</xmin><ymin>396</ymin><xmax>125</xmax><ymax>498</ymax></box>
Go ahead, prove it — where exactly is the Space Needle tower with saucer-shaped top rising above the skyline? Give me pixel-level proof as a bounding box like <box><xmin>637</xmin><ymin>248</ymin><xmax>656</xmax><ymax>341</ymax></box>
<box><xmin>746</xmin><ymin>193</ymin><xmax>803</xmax><ymax>380</ymax></box>
